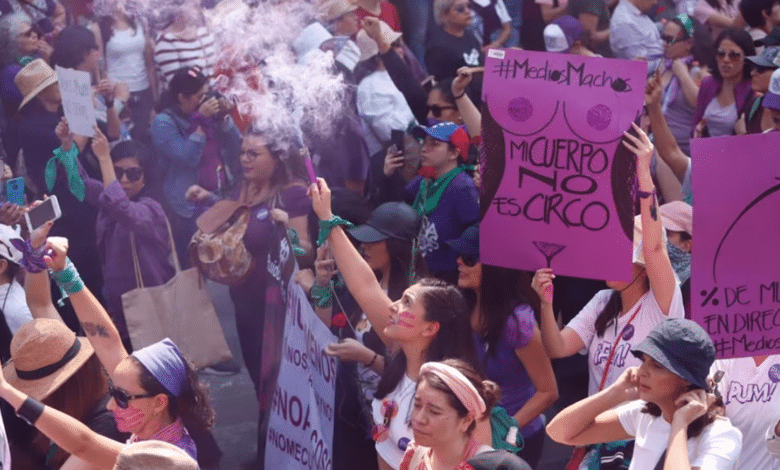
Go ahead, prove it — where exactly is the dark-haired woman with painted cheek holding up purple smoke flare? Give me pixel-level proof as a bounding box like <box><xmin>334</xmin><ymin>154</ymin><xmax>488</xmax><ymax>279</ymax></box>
<box><xmin>309</xmin><ymin>178</ymin><xmax>478</xmax><ymax>470</ymax></box>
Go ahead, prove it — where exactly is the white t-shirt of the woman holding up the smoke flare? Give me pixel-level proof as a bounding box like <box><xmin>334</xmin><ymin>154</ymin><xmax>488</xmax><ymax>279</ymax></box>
<box><xmin>371</xmin><ymin>374</ymin><xmax>417</xmax><ymax>469</ymax></box>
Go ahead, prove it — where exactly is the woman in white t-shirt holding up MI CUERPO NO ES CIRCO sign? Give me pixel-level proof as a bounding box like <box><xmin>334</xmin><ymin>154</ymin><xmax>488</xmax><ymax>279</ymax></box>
<box><xmin>532</xmin><ymin>124</ymin><xmax>684</xmax><ymax>470</ymax></box>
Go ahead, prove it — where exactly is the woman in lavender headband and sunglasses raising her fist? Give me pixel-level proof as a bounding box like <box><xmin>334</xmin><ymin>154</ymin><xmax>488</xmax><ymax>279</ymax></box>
<box><xmin>28</xmin><ymin>238</ymin><xmax>220</xmax><ymax>468</ymax></box>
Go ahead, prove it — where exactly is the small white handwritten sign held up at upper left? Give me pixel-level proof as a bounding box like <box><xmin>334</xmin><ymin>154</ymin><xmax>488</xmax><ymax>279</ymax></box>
<box><xmin>56</xmin><ymin>66</ymin><xmax>97</xmax><ymax>137</ymax></box>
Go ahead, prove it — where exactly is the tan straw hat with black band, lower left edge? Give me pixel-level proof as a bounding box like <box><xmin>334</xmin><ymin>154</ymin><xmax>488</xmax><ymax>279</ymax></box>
<box><xmin>3</xmin><ymin>318</ymin><xmax>95</xmax><ymax>400</ymax></box>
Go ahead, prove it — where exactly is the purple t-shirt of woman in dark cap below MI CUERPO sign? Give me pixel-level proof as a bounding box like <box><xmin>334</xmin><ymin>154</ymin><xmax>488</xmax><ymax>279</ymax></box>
<box><xmin>474</xmin><ymin>304</ymin><xmax>543</xmax><ymax>437</ymax></box>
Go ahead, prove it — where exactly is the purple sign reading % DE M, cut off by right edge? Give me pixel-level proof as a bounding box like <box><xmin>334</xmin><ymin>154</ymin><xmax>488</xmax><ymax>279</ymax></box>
<box><xmin>691</xmin><ymin>132</ymin><xmax>780</xmax><ymax>358</ymax></box>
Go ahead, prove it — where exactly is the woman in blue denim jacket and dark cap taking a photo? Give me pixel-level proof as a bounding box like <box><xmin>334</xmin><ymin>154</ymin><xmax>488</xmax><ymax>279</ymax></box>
<box><xmin>150</xmin><ymin>67</ymin><xmax>241</xmax><ymax>265</ymax></box>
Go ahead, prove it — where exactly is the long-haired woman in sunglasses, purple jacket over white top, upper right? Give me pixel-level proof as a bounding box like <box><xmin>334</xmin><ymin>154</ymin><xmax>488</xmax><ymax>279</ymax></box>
<box><xmin>693</xmin><ymin>28</ymin><xmax>756</xmax><ymax>137</ymax></box>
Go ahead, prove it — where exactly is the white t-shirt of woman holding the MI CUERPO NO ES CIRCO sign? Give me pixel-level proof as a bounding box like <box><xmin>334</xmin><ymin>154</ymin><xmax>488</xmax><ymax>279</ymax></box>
<box><xmin>566</xmin><ymin>285</ymin><xmax>685</xmax><ymax>395</ymax></box>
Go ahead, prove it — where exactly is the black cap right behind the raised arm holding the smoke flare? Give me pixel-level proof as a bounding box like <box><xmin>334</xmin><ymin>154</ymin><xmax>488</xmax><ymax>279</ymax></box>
<box><xmin>349</xmin><ymin>202</ymin><xmax>422</xmax><ymax>243</ymax></box>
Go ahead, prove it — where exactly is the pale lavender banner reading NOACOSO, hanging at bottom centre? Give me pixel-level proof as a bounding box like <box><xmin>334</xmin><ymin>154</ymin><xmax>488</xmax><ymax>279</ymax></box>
<box><xmin>265</xmin><ymin>268</ymin><xmax>338</xmax><ymax>470</ymax></box>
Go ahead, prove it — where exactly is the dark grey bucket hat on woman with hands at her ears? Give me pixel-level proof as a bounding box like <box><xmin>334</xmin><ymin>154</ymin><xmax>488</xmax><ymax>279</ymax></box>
<box><xmin>631</xmin><ymin>318</ymin><xmax>715</xmax><ymax>390</ymax></box>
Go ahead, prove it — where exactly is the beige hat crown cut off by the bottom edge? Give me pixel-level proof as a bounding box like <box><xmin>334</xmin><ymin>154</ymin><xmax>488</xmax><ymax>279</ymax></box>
<box><xmin>113</xmin><ymin>440</ymin><xmax>198</xmax><ymax>470</ymax></box>
